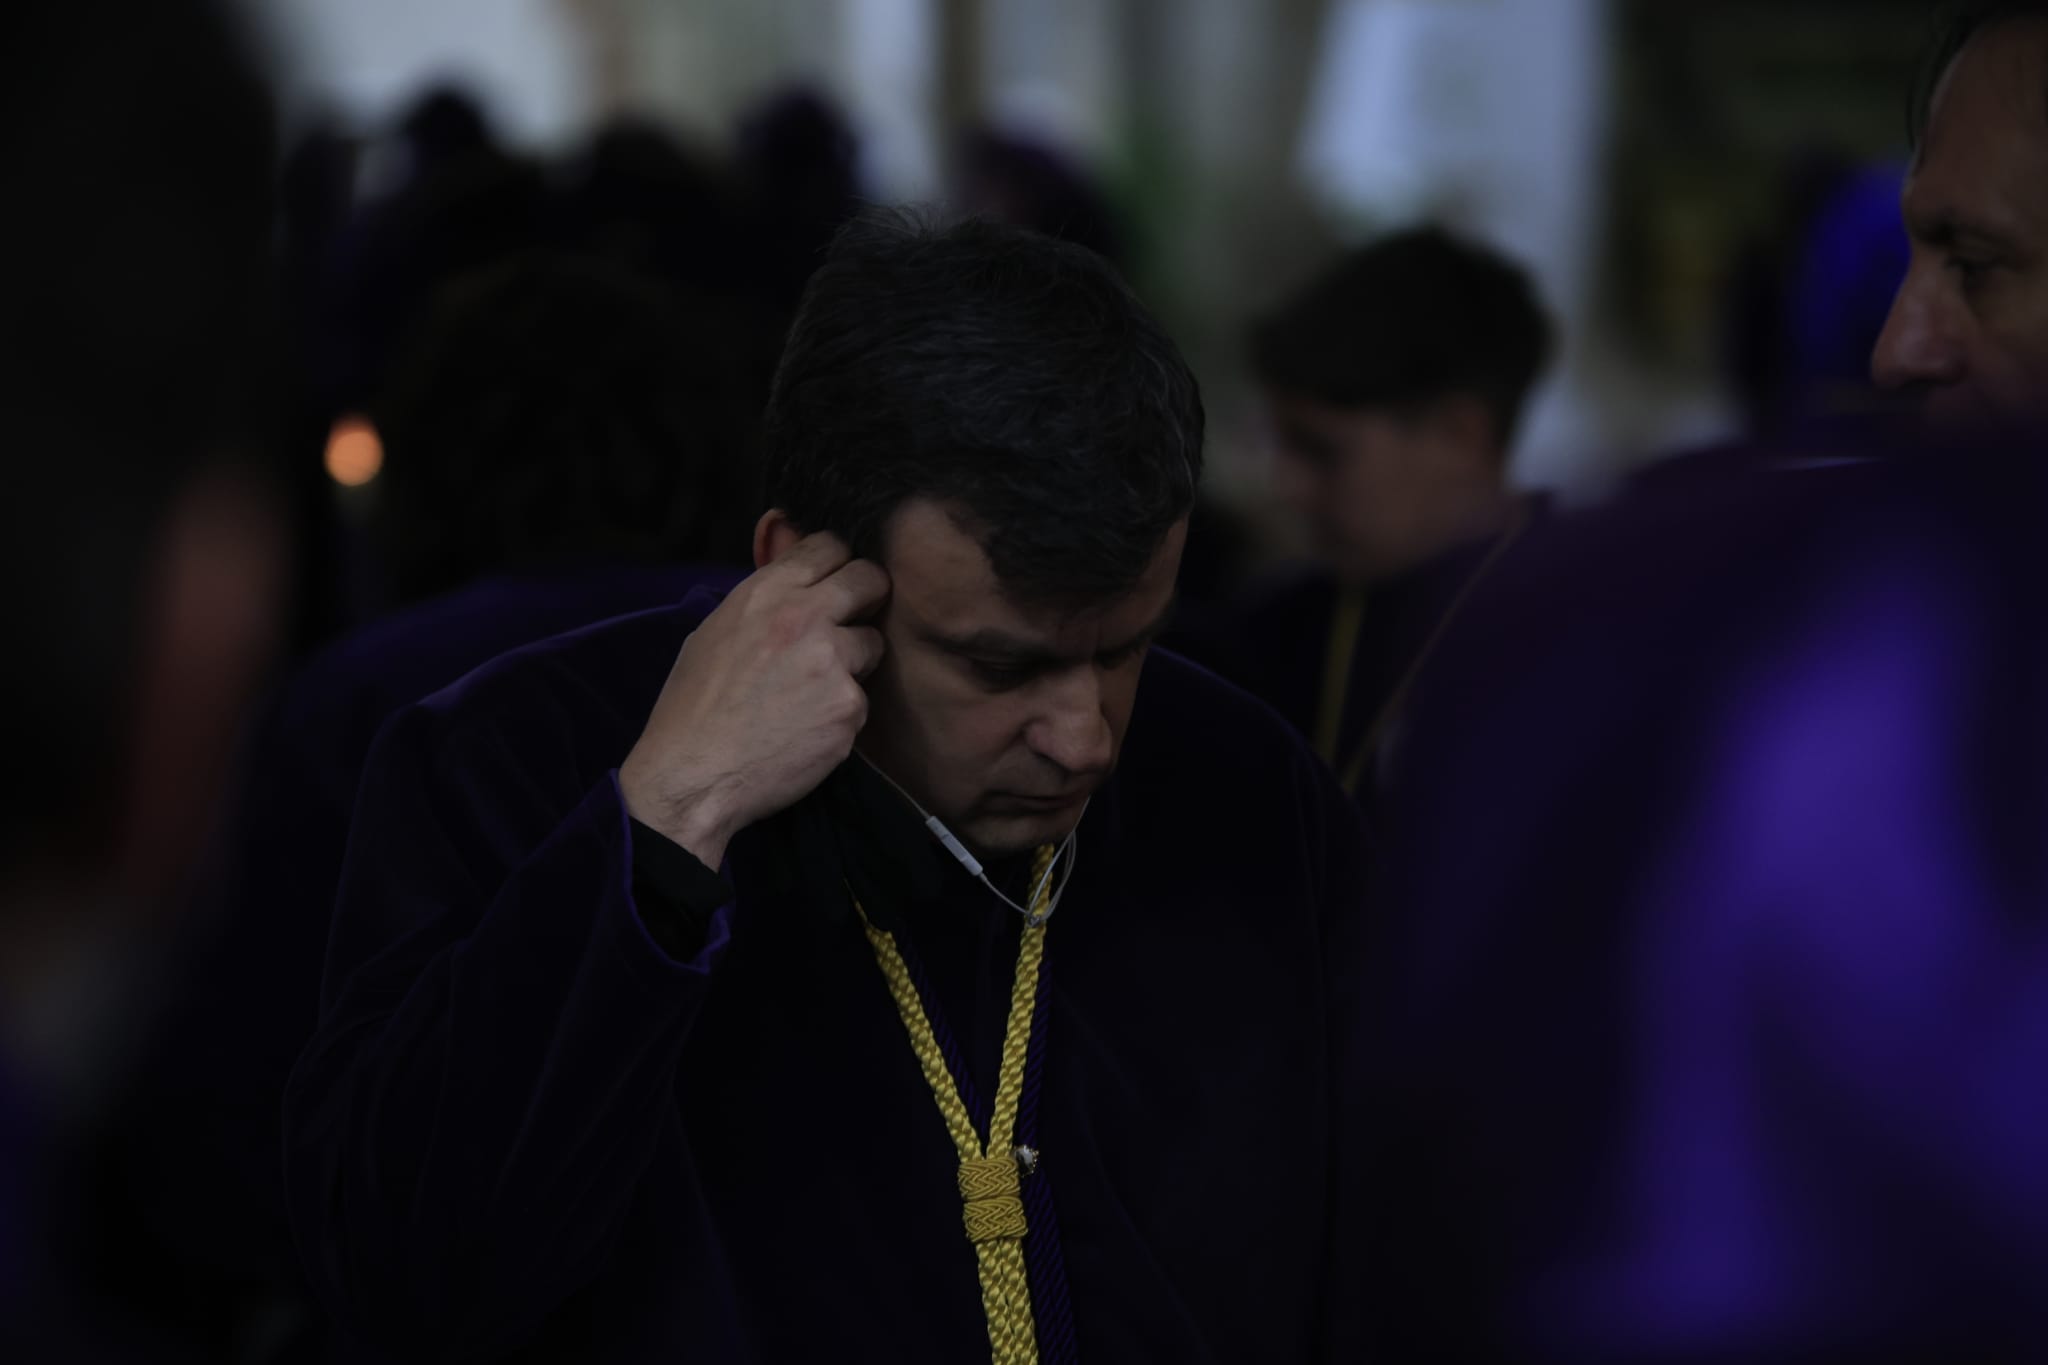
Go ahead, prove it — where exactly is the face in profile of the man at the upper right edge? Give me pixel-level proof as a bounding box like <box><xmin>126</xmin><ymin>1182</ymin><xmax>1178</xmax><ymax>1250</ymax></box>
<box><xmin>1872</xmin><ymin>18</ymin><xmax>2048</xmax><ymax>426</ymax></box>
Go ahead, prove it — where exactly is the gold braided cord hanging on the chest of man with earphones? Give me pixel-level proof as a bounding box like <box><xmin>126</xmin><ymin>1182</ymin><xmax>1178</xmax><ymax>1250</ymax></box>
<box><xmin>854</xmin><ymin>845</ymin><xmax>1053</xmax><ymax>1365</ymax></box>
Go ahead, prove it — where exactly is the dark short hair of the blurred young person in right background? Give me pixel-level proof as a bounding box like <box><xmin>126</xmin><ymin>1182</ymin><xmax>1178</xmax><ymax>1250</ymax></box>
<box><xmin>1251</xmin><ymin>227</ymin><xmax>1552</xmax><ymax>450</ymax></box>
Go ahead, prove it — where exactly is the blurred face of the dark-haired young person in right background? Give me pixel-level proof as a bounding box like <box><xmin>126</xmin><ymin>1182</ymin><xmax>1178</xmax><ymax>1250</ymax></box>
<box><xmin>1268</xmin><ymin>393</ymin><xmax>1503</xmax><ymax>583</ymax></box>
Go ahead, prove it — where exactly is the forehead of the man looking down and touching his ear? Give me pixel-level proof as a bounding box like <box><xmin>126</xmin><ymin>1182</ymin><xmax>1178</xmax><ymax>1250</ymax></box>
<box><xmin>883</xmin><ymin>499</ymin><xmax>1186</xmax><ymax>653</ymax></box>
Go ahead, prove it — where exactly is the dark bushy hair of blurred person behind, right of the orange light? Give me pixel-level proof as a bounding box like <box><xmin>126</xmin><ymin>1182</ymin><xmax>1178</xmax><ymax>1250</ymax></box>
<box><xmin>375</xmin><ymin>252</ymin><xmax>750</xmax><ymax>600</ymax></box>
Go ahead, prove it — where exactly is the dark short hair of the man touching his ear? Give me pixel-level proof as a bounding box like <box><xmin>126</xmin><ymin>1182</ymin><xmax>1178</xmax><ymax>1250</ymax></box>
<box><xmin>764</xmin><ymin>211</ymin><xmax>1202</xmax><ymax>602</ymax></box>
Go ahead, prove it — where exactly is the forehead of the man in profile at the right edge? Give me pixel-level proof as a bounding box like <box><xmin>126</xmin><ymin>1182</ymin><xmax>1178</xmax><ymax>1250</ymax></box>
<box><xmin>1905</xmin><ymin>18</ymin><xmax>2048</xmax><ymax>239</ymax></box>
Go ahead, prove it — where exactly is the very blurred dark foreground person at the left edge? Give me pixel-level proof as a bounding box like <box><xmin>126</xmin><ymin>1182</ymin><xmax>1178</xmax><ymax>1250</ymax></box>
<box><xmin>0</xmin><ymin>0</ymin><xmax>289</xmax><ymax>1361</ymax></box>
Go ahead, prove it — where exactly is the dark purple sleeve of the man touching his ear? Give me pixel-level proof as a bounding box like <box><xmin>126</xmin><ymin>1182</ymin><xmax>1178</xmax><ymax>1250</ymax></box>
<box><xmin>285</xmin><ymin>704</ymin><xmax>731</xmax><ymax>1359</ymax></box>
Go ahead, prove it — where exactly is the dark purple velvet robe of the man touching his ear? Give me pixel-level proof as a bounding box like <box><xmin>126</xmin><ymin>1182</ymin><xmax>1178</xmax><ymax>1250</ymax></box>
<box><xmin>287</xmin><ymin>596</ymin><xmax>1362</xmax><ymax>1363</ymax></box>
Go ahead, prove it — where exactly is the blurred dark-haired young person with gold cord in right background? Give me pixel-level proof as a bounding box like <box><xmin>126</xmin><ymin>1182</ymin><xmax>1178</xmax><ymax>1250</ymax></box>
<box><xmin>1176</xmin><ymin>229</ymin><xmax>1550</xmax><ymax>798</ymax></box>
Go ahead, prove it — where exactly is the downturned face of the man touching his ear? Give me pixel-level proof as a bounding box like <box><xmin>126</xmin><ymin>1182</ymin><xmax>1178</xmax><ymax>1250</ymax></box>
<box><xmin>860</xmin><ymin>499</ymin><xmax>1186</xmax><ymax>857</ymax></box>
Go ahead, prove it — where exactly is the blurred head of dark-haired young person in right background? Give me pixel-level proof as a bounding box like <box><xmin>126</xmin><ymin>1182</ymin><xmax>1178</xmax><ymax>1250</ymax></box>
<box><xmin>1251</xmin><ymin>229</ymin><xmax>1550</xmax><ymax>583</ymax></box>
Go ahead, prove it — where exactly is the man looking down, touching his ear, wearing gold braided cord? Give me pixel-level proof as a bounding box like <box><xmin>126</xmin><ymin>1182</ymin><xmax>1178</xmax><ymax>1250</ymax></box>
<box><xmin>287</xmin><ymin>208</ymin><xmax>1360</xmax><ymax>1361</ymax></box>
